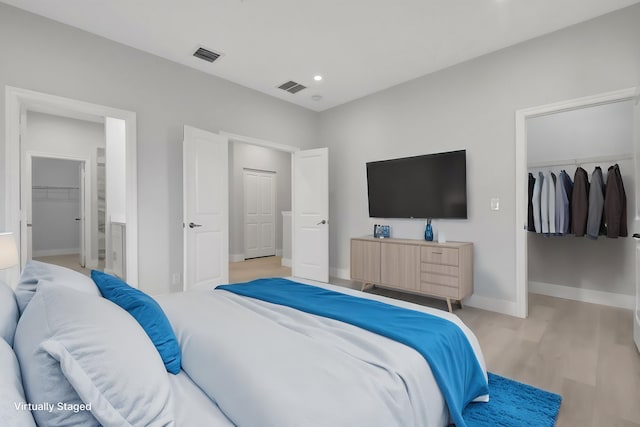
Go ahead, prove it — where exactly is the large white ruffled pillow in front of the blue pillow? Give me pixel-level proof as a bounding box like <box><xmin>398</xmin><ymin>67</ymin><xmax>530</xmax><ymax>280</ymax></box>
<box><xmin>15</xmin><ymin>280</ymin><xmax>174</xmax><ymax>426</ymax></box>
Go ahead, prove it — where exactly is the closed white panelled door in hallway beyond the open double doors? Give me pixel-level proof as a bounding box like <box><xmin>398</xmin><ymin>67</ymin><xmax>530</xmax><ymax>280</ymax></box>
<box><xmin>243</xmin><ymin>169</ymin><xmax>276</xmax><ymax>258</ymax></box>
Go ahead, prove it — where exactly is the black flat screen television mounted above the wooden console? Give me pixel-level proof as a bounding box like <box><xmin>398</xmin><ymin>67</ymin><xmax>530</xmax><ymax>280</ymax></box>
<box><xmin>367</xmin><ymin>150</ymin><xmax>467</xmax><ymax>219</ymax></box>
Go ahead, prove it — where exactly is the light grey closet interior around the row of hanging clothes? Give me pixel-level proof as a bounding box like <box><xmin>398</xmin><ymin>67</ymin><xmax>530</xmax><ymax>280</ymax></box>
<box><xmin>526</xmin><ymin>101</ymin><xmax>636</xmax><ymax>305</ymax></box>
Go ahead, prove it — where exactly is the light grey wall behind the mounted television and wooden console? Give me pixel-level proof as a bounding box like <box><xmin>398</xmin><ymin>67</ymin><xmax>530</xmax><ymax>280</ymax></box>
<box><xmin>321</xmin><ymin>5</ymin><xmax>640</xmax><ymax>312</ymax></box>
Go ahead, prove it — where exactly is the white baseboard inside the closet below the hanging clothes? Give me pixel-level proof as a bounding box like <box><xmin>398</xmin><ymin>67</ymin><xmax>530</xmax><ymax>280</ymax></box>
<box><xmin>529</xmin><ymin>281</ymin><xmax>636</xmax><ymax>310</ymax></box>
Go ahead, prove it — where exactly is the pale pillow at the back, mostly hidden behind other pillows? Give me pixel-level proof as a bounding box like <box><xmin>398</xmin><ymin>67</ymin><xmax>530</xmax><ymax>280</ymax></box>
<box><xmin>16</xmin><ymin>260</ymin><xmax>100</xmax><ymax>314</ymax></box>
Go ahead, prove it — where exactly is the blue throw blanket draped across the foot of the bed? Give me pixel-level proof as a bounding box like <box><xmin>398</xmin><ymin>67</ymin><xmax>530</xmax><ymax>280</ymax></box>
<box><xmin>216</xmin><ymin>279</ymin><xmax>489</xmax><ymax>427</ymax></box>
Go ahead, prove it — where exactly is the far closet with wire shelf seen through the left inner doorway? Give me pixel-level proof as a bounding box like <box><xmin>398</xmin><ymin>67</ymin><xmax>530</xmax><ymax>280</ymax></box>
<box><xmin>31</xmin><ymin>157</ymin><xmax>80</xmax><ymax>257</ymax></box>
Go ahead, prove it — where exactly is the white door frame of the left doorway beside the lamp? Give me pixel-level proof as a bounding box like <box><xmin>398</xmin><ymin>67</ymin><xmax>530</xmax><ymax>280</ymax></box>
<box><xmin>4</xmin><ymin>86</ymin><xmax>138</xmax><ymax>287</ymax></box>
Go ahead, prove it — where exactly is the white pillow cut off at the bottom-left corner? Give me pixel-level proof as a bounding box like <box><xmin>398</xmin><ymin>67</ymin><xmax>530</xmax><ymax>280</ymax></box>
<box><xmin>0</xmin><ymin>340</ymin><xmax>36</xmax><ymax>427</ymax></box>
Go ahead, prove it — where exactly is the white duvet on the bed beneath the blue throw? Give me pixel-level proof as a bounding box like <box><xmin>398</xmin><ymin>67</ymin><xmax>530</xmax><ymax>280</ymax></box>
<box><xmin>157</xmin><ymin>281</ymin><xmax>486</xmax><ymax>427</ymax></box>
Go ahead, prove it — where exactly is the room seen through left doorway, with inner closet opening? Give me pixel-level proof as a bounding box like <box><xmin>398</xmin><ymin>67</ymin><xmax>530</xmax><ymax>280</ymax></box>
<box><xmin>20</xmin><ymin>111</ymin><xmax>105</xmax><ymax>274</ymax></box>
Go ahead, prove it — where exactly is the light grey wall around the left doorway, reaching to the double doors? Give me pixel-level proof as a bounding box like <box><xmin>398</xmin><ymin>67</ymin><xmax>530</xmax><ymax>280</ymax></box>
<box><xmin>0</xmin><ymin>3</ymin><xmax>318</xmax><ymax>293</ymax></box>
